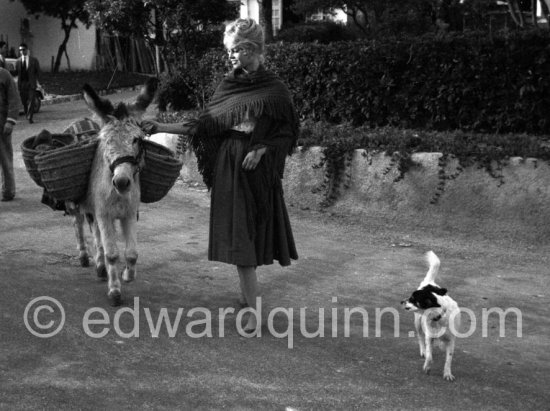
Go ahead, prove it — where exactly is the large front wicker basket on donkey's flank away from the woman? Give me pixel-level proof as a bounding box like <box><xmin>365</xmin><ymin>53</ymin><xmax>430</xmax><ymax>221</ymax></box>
<box><xmin>35</xmin><ymin>139</ymin><xmax>99</xmax><ymax>201</ymax></box>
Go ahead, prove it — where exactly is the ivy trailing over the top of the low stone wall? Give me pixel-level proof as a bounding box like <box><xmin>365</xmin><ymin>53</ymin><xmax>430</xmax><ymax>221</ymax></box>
<box><xmin>299</xmin><ymin>121</ymin><xmax>550</xmax><ymax>206</ymax></box>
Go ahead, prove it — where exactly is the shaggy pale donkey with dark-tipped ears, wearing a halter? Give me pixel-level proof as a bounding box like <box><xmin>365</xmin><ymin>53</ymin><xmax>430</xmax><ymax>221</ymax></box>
<box><xmin>75</xmin><ymin>79</ymin><xmax>158</xmax><ymax>306</ymax></box>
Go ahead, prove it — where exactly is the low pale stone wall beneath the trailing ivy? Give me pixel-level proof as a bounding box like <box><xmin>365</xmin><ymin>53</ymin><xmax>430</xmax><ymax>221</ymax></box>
<box><xmin>182</xmin><ymin>147</ymin><xmax>550</xmax><ymax>238</ymax></box>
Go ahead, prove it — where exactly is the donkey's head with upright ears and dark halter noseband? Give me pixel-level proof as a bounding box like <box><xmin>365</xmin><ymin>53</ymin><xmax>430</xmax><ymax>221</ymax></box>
<box><xmin>83</xmin><ymin>79</ymin><xmax>158</xmax><ymax>194</ymax></box>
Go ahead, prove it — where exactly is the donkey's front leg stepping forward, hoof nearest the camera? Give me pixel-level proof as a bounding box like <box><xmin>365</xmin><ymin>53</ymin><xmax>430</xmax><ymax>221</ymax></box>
<box><xmin>96</xmin><ymin>216</ymin><xmax>122</xmax><ymax>305</ymax></box>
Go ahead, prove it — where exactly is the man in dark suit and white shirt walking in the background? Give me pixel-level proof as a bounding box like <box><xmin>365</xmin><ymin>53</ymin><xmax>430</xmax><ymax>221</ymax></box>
<box><xmin>15</xmin><ymin>43</ymin><xmax>40</xmax><ymax>124</ymax></box>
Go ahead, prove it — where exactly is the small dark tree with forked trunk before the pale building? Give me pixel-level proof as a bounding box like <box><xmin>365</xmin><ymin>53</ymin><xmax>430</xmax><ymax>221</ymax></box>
<box><xmin>10</xmin><ymin>0</ymin><xmax>90</xmax><ymax>73</ymax></box>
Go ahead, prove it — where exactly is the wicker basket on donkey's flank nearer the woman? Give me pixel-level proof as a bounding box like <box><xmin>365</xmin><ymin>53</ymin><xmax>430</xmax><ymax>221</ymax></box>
<box><xmin>139</xmin><ymin>140</ymin><xmax>183</xmax><ymax>203</ymax></box>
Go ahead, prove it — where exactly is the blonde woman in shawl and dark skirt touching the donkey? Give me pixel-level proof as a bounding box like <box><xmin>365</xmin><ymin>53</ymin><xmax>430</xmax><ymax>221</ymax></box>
<box><xmin>144</xmin><ymin>19</ymin><xmax>299</xmax><ymax>333</ymax></box>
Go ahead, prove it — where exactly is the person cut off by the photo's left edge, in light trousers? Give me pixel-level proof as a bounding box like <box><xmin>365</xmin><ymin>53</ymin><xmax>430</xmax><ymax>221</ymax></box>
<box><xmin>0</xmin><ymin>68</ymin><xmax>21</xmax><ymax>201</ymax></box>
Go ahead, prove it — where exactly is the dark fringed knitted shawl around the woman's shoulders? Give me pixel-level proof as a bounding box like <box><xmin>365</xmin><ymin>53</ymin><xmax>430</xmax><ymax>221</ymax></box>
<box><xmin>191</xmin><ymin>66</ymin><xmax>299</xmax><ymax>188</ymax></box>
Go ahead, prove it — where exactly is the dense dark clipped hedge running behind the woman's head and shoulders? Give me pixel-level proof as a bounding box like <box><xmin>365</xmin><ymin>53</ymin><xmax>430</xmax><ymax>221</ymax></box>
<box><xmin>162</xmin><ymin>31</ymin><xmax>550</xmax><ymax>134</ymax></box>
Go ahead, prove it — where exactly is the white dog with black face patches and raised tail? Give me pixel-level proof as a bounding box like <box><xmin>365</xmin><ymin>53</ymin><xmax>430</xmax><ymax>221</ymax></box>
<box><xmin>401</xmin><ymin>251</ymin><xmax>460</xmax><ymax>381</ymax></box>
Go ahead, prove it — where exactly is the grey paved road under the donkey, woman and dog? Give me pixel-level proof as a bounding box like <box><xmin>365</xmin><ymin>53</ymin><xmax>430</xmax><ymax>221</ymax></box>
<box><xmin>0</xmin><ymin>92</ymin><xmax>550</xmax><ymax>410</ymax></box>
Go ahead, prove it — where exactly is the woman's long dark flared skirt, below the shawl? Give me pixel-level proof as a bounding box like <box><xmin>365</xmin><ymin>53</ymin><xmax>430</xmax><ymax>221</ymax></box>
<box><xmin>208</xmin><ymin>138</ymin><xmax>298</xmax><ymax>266</ymax></box>
